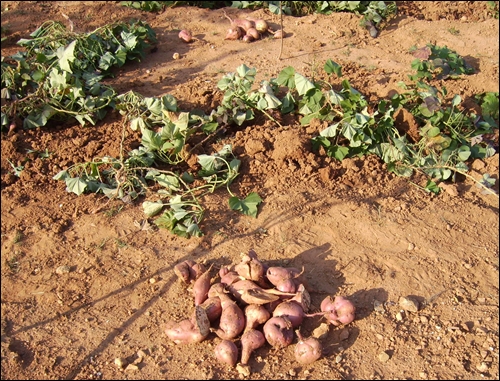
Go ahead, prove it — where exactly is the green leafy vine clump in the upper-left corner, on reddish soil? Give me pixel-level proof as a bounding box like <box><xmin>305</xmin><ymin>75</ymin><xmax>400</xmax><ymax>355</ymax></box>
<box><xmin>1</xmin><ymin>21</ymin><xmax>156</xmax><ymax>130</ymax></box>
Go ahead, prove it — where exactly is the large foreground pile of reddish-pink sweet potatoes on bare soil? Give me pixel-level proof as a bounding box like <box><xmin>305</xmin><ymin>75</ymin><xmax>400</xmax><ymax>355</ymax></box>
<box><xmin>165</xmin><ymin>250</ymin><xmax>356</xmax><ymax>372</ymax></box>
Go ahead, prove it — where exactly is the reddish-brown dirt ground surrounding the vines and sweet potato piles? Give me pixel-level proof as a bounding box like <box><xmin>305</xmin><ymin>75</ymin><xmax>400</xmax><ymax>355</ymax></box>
<box><xmin>1</xmin><ymin>1</ymin><xmax>499</xmax><ymax>380</ymax></box>
